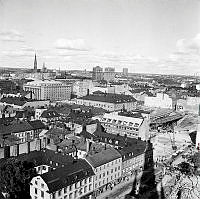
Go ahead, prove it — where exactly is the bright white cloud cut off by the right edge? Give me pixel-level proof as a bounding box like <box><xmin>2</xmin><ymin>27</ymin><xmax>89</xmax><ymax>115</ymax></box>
<box><xmin>176</xmin><ymin>34</ymin><xmax>200</xmax><ymax>54</ymax></box>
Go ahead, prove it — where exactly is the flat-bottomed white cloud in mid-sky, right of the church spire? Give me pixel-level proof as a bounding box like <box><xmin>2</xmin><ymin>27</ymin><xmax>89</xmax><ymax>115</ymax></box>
<box><xmin>54</xmin><ymin>39</ymin><xmax>89</xmax><ymax>51</ymax></box>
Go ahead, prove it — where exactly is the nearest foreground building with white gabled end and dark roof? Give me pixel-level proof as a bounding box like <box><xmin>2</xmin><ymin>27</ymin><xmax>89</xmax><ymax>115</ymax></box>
<box><xmin>30</xmin><ymin>160</ymin><xmax>94</xmax><ymax>199</ymax></box>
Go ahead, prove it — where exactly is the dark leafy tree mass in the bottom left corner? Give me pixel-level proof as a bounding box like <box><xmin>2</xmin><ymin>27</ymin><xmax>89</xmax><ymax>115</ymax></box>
<box><xmin>0</xmin><ymin>159</ymin><xmax>36</xmax><ymax>199</ymax></box>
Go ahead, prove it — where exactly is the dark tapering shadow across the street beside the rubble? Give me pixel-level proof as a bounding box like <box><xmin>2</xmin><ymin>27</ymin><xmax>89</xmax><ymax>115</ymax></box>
<box><xmin>125</xmin><ymin>141</ymin><xmax>165</xmax><ymax>199</ymax></box>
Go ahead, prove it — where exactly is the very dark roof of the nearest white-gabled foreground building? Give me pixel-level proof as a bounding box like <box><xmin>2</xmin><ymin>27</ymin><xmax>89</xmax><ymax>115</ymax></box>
<box><xmin>41</xmin><ymin>159</ymin><xmax>94</xmax><ymax>193</ymax></box>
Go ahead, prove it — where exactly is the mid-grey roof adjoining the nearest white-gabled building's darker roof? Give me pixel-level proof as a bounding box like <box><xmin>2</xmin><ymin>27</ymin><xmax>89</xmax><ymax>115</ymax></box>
<box><xmin>86</xmin><ymin>148</ymin><xmax>121</xmax><ymax>168</ymax></box>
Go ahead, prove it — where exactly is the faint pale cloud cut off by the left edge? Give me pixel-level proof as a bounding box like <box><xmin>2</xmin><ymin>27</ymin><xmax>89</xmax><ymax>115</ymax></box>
<box><xmin>0</xmin><ymin>30</ymin><xmax>24</xmax><ymax>42</ymax></box>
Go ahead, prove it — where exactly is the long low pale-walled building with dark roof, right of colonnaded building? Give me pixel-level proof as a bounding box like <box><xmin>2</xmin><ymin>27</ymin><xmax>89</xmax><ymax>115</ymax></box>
<box><xmin>76</xmin><ymin>93</ymin><xmax>137</xmax><ymax>111</ymax></box>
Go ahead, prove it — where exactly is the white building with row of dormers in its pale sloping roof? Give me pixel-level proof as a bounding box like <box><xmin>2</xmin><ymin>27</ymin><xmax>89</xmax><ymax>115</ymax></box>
<box><xmin>100</xmin><ymin>112</ymin><xmax>149</xmax><ymax>140</ymax></box>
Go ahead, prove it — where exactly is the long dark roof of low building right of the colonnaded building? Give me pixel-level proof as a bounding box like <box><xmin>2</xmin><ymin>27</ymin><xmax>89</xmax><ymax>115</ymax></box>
<box><xmin>79</xmin><ymin>93</ymin><xmax>137</xmax><ymax>104</ymax></box>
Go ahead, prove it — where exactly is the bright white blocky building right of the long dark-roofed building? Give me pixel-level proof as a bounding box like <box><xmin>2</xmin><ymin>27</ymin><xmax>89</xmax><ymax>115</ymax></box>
<box><xmin>144</xmin><ymin>93</ymin><xmax>173</xmax><ymax>109</ymax></box>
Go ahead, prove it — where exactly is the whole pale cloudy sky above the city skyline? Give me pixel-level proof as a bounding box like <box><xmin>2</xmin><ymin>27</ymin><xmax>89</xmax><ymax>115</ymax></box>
<box><xmin>0</xmin><ymin>0</ymin><xmax>200</xmax><ymax>75</ymax></box>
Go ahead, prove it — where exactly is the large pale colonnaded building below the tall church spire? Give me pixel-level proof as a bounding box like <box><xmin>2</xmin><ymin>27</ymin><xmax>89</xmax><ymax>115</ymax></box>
<box><xmin>23</xmin><ymin>80</ymin><xmax>71</xmax><ymax>101</ymax></box>
